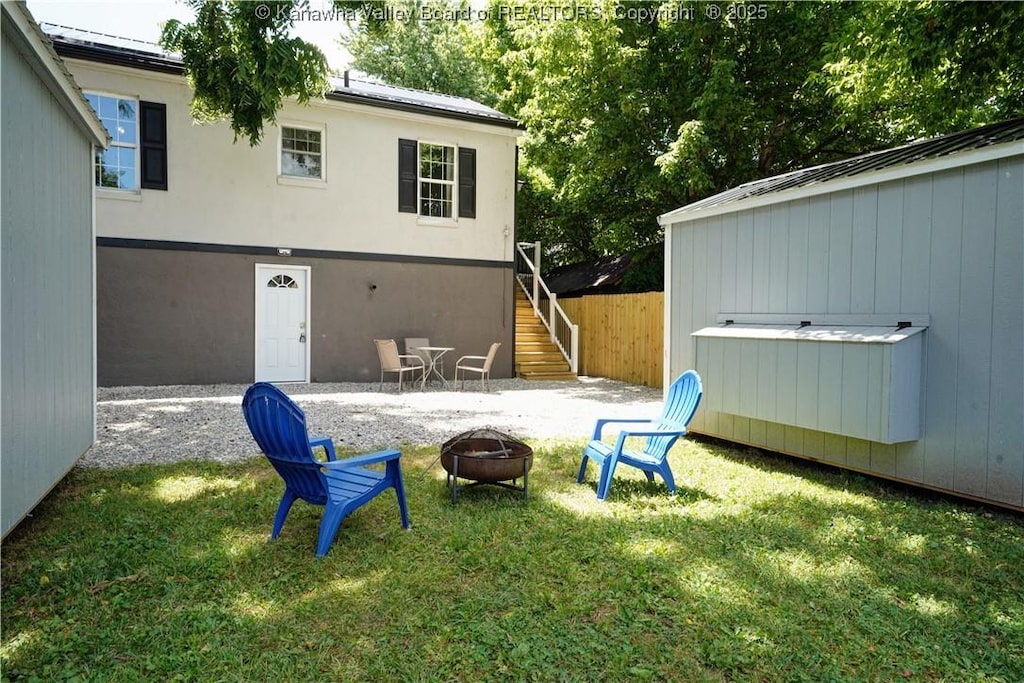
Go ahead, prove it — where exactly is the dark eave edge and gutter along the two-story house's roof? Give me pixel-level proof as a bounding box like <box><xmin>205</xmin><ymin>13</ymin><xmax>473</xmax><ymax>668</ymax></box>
<box><xmin>50</xmin><ymin>36</ymin><xmax>525</xmax><ymax>130</ymax></box>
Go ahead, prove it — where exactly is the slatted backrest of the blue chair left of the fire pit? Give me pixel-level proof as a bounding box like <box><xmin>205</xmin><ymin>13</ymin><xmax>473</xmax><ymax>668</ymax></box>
<box><xmin>242</xmin><ymin>382</ymin><xmax>327</xmax><ymax>505</ymax></box>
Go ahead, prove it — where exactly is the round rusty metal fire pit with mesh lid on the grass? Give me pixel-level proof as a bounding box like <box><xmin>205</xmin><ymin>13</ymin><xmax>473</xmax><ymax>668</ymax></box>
<box><xmin>441</xmin><ymin>429</ymin><xmax>534</xmax><ymax>503</ymax></box>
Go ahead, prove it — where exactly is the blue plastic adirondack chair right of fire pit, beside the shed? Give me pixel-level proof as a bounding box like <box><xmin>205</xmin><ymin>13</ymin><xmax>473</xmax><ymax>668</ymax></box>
<box><xmin>577</xmin><ymin>370</ymin><xmax>703</xmax><ymax>501</ymax></box>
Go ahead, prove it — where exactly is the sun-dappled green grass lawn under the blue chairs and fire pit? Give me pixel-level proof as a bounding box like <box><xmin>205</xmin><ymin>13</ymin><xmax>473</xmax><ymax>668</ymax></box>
<box><xmin>2</xmin><ymin>440</ymin><xmax>1024</xmax><ymax>682</ymax></box>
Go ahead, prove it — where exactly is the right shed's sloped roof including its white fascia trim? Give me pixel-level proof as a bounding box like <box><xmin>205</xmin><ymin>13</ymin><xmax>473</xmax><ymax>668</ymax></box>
<box><xmin>658</xmin><ymin>118</ymin><xmax>1024</xmax><ymax>225</ymax></box>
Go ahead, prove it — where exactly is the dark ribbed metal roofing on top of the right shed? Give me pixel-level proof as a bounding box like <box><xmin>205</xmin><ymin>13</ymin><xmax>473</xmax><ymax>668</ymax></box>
<box><xmin>662</xmin><ymin>118</ymin><xmax>1024</xmax><ymax>223</ymax></box>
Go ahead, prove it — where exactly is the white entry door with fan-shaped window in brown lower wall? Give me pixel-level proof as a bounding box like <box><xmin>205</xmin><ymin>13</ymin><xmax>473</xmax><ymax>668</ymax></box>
<box><xmin>256</xmin><ymin>263</ymin><xmax>309</xmax><ymax>382</ymax></box>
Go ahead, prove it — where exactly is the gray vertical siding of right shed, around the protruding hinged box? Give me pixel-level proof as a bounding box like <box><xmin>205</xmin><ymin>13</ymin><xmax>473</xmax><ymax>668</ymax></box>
<box><xmin>667</xmin><ymin>155</ymin><xmax>1024</xmax><ymax>508</ymax></box>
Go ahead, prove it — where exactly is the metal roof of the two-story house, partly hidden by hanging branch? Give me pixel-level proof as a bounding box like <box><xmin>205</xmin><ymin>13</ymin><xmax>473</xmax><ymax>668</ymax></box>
<box><xmin>43</xmin><ymin>24</ymin><xmax>522</xmax><ymax>129</ymax></box>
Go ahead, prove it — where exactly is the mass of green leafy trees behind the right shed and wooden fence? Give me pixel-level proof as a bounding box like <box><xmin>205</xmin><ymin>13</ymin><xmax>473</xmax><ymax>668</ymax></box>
<box><xmin>487</xmin><ymin>0</ymin><xmax>1024</xmax><ymax>282</ymax></box>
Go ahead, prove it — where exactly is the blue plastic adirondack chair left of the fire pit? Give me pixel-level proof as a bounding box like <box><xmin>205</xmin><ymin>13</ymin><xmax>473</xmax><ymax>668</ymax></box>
<box><xmin>242</xmin><ymin>382</ymin><xmax>409</xmax><ymax>557</ymax></box>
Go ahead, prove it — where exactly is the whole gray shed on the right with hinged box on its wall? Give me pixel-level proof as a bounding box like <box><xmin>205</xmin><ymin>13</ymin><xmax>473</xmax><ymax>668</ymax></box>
<box><xmin>658</xmin><ymin>119</ymin><xmax>1024</xmax><ymax>510</ymax></box>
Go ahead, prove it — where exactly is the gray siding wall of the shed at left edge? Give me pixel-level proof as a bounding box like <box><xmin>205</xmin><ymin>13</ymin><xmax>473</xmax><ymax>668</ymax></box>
<box><xmin>0</xmin><ymin>22</ymin><xmax>95</xmax><ymax>536</ymax></box>
